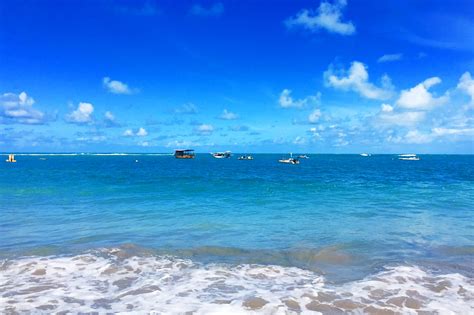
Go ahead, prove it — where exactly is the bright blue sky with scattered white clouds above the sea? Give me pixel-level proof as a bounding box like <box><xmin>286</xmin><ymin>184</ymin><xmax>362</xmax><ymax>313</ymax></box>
<box><xmin>0</xmin><ymin>0</ymin><xmax>474</xmax><ymax>153</ymax></box>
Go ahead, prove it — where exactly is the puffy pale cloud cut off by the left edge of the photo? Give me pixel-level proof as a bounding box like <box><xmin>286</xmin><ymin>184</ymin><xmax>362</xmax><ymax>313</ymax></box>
<box><xmin>0</xmin><ymin>92</ymin><xmax>46</xmax><ymax>125</ymax></box>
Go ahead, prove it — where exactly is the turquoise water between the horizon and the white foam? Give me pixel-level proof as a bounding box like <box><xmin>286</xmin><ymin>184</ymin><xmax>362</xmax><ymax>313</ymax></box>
<box><xmin>0</xmin><ymin>154</ymin><xmax>474</xmax><ymax>314</ymax></box>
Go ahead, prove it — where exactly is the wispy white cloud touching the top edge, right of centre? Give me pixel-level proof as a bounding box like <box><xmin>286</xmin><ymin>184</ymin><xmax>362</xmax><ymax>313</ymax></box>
<box><xmin>285</xmin><ymin>0</ymin><xmax>356</xmax><ymax>35</ymax></box>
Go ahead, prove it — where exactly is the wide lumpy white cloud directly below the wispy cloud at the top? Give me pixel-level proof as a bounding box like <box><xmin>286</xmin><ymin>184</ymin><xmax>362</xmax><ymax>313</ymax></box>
<box><xmin>324</xmin><ymin>61</ymin><xmax>393</xmax><ymax>100</ymax></box>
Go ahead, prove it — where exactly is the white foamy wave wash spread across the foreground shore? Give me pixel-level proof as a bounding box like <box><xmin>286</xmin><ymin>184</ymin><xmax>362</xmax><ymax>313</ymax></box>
<box><xmin>0</xmin><ymin>253</ymin><xmax>474</xmax><ymax>314</ymax></box>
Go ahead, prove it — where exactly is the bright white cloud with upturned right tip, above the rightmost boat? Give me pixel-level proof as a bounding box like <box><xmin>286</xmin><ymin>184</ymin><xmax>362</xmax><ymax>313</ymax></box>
<box><xmin>396</xmin><ymin>77</ymin><xmax>449</xmax><ymax>110</ymax></box>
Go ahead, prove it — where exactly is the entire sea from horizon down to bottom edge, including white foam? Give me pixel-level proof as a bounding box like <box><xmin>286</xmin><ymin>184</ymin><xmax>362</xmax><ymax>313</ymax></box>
<box><xmin>0</xmin><ymin>154</ymin><xmax>474</xmax><ymax>314</ymax></box>
